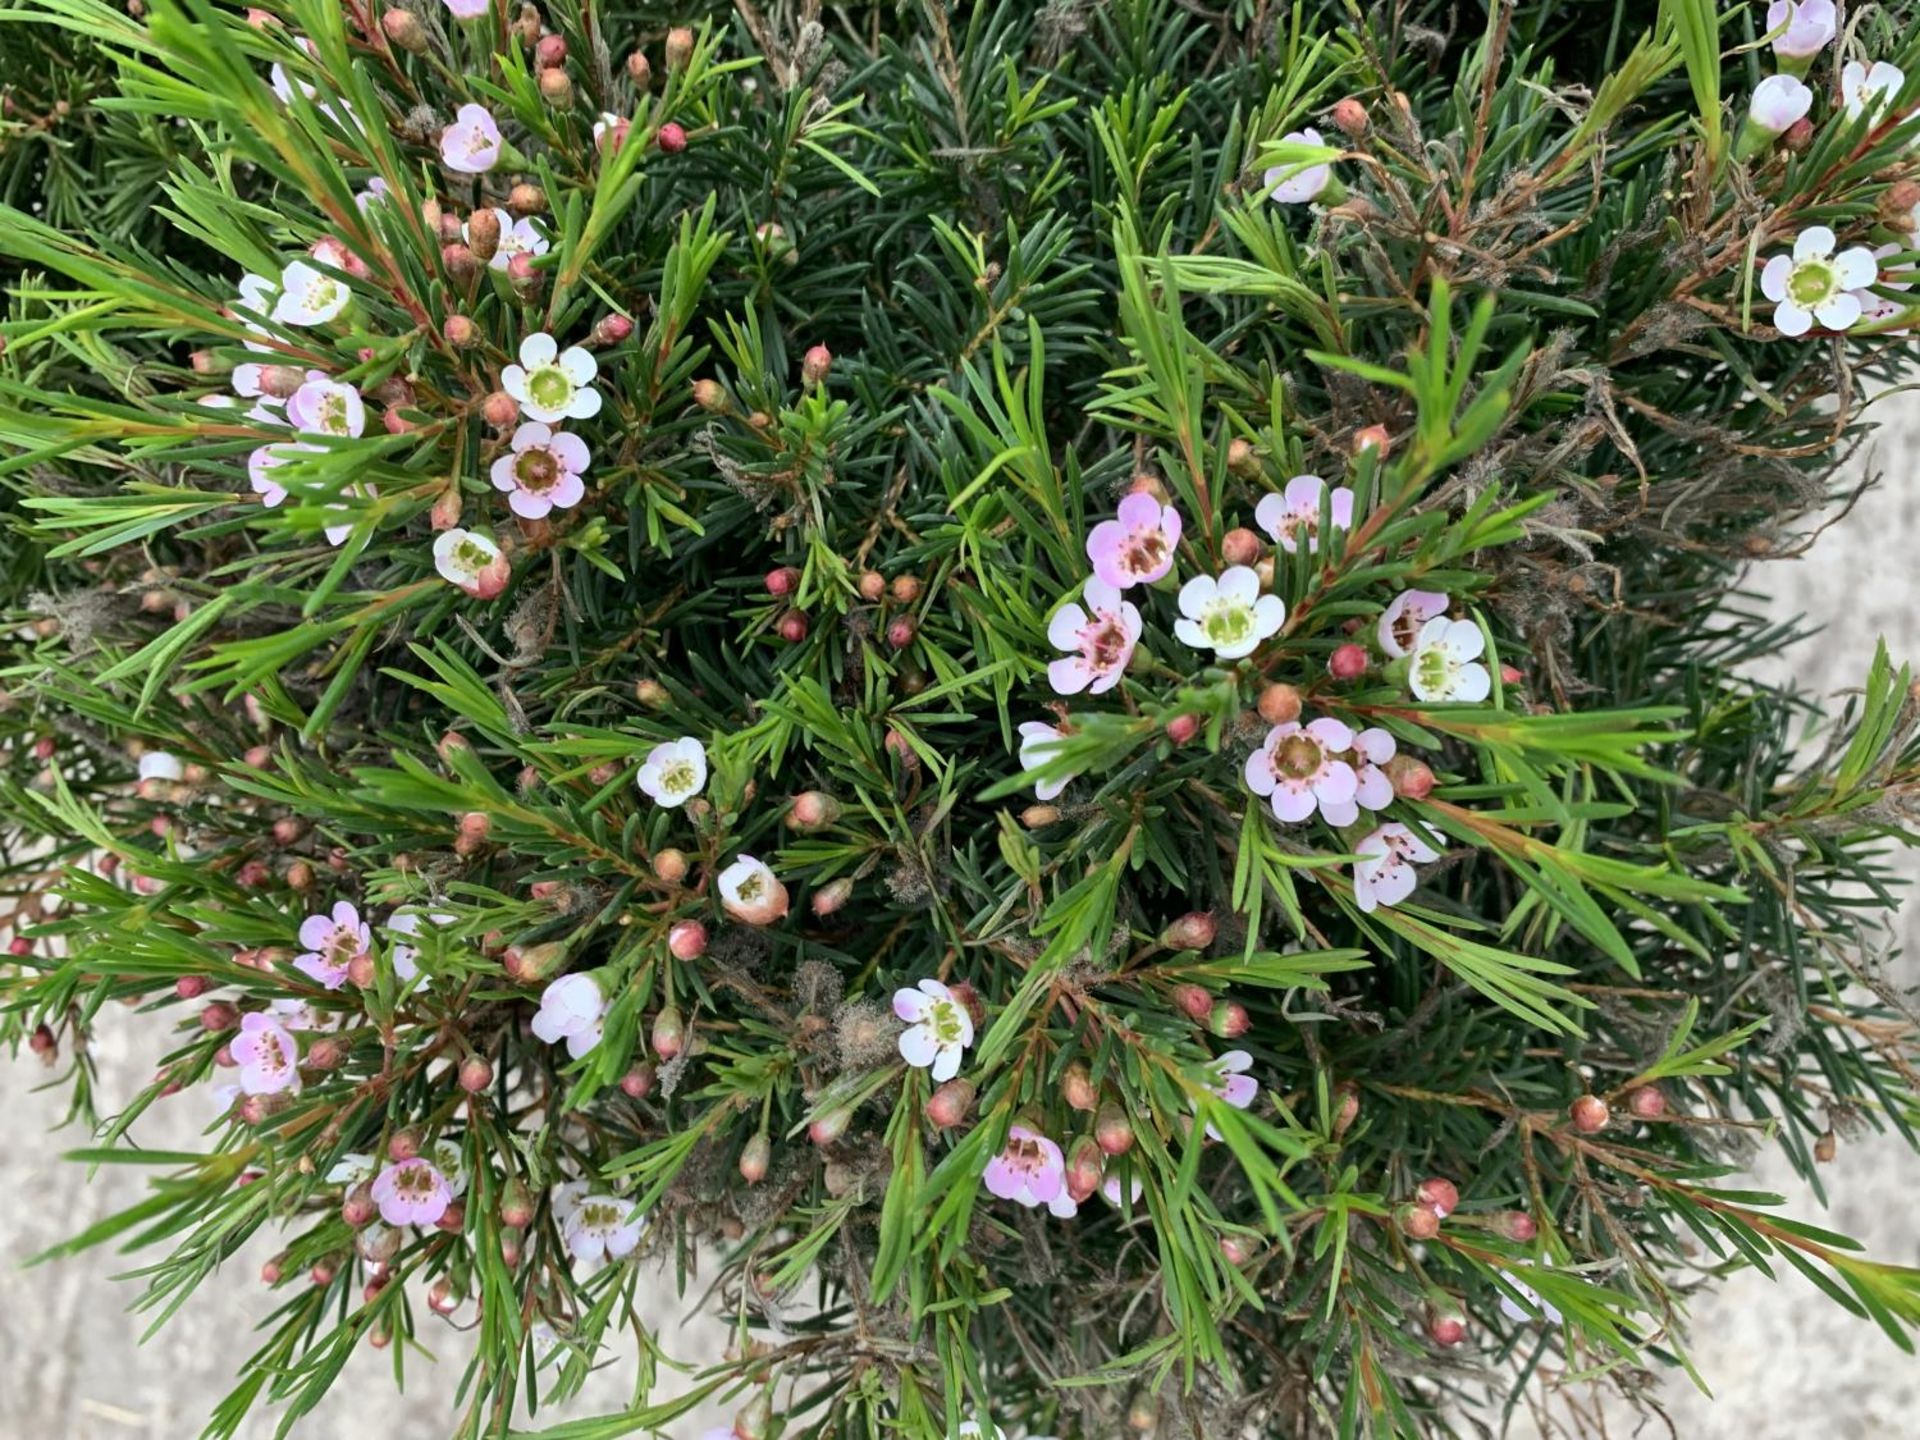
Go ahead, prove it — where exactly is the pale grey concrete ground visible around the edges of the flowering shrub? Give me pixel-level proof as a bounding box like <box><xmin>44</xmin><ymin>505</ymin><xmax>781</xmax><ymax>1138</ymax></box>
<box><xmin>0</xmin><ymin>396</ymin><xmax>1920</xmax><ymax>1440</ymax></box>
